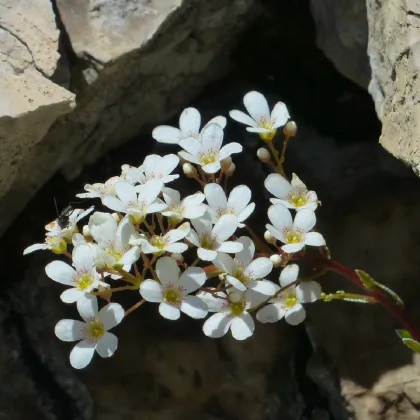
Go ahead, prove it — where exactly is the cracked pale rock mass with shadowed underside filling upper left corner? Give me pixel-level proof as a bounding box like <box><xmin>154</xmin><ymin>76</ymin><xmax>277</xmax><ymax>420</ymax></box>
<box><xmin>0</xmin><ymin>0</ymin><xmax>258</xmax><ymax>238</ymax></box>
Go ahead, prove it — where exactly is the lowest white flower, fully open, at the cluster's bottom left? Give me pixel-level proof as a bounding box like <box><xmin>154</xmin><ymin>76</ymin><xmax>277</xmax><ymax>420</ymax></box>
<box><xmin>54</xmin><ymin>295</ymin><xmax>124</xmax><ymax>369</ymax></box>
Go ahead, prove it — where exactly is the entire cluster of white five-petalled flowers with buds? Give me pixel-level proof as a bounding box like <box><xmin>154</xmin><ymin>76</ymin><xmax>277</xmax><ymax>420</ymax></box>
<box><xmin>24</xmin><ymin>92</ymin><xmax>325</xmax><ymax>369</ymax></box>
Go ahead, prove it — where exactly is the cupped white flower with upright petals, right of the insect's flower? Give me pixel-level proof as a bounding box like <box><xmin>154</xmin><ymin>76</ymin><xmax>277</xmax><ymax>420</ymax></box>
<box><xmin>88</xmin><ymin>212</ymin><xmax>140</xmax><ymax>271</ymax></box>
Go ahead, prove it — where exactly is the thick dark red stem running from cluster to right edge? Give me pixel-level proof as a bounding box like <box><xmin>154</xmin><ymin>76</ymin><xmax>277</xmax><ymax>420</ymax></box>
<box><xmin>324</xmin><ymin>259</ymin><xmax>420</xmax><ymax>341</ymax></box>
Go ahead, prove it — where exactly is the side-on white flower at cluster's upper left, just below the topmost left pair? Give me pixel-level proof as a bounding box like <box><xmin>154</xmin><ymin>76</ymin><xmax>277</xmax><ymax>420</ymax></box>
<box><xmin>122</xmin><ymin>155</ymin><xmax>179</xmax><ymax>184</ymax></box>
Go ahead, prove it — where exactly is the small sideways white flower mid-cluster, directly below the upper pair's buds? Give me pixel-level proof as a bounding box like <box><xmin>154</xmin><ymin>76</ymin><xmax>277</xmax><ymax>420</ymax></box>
<box><xmin>162</xmin><ymin>187</ymin><xmax>206</xmax><ymax>223</ymax></box>
